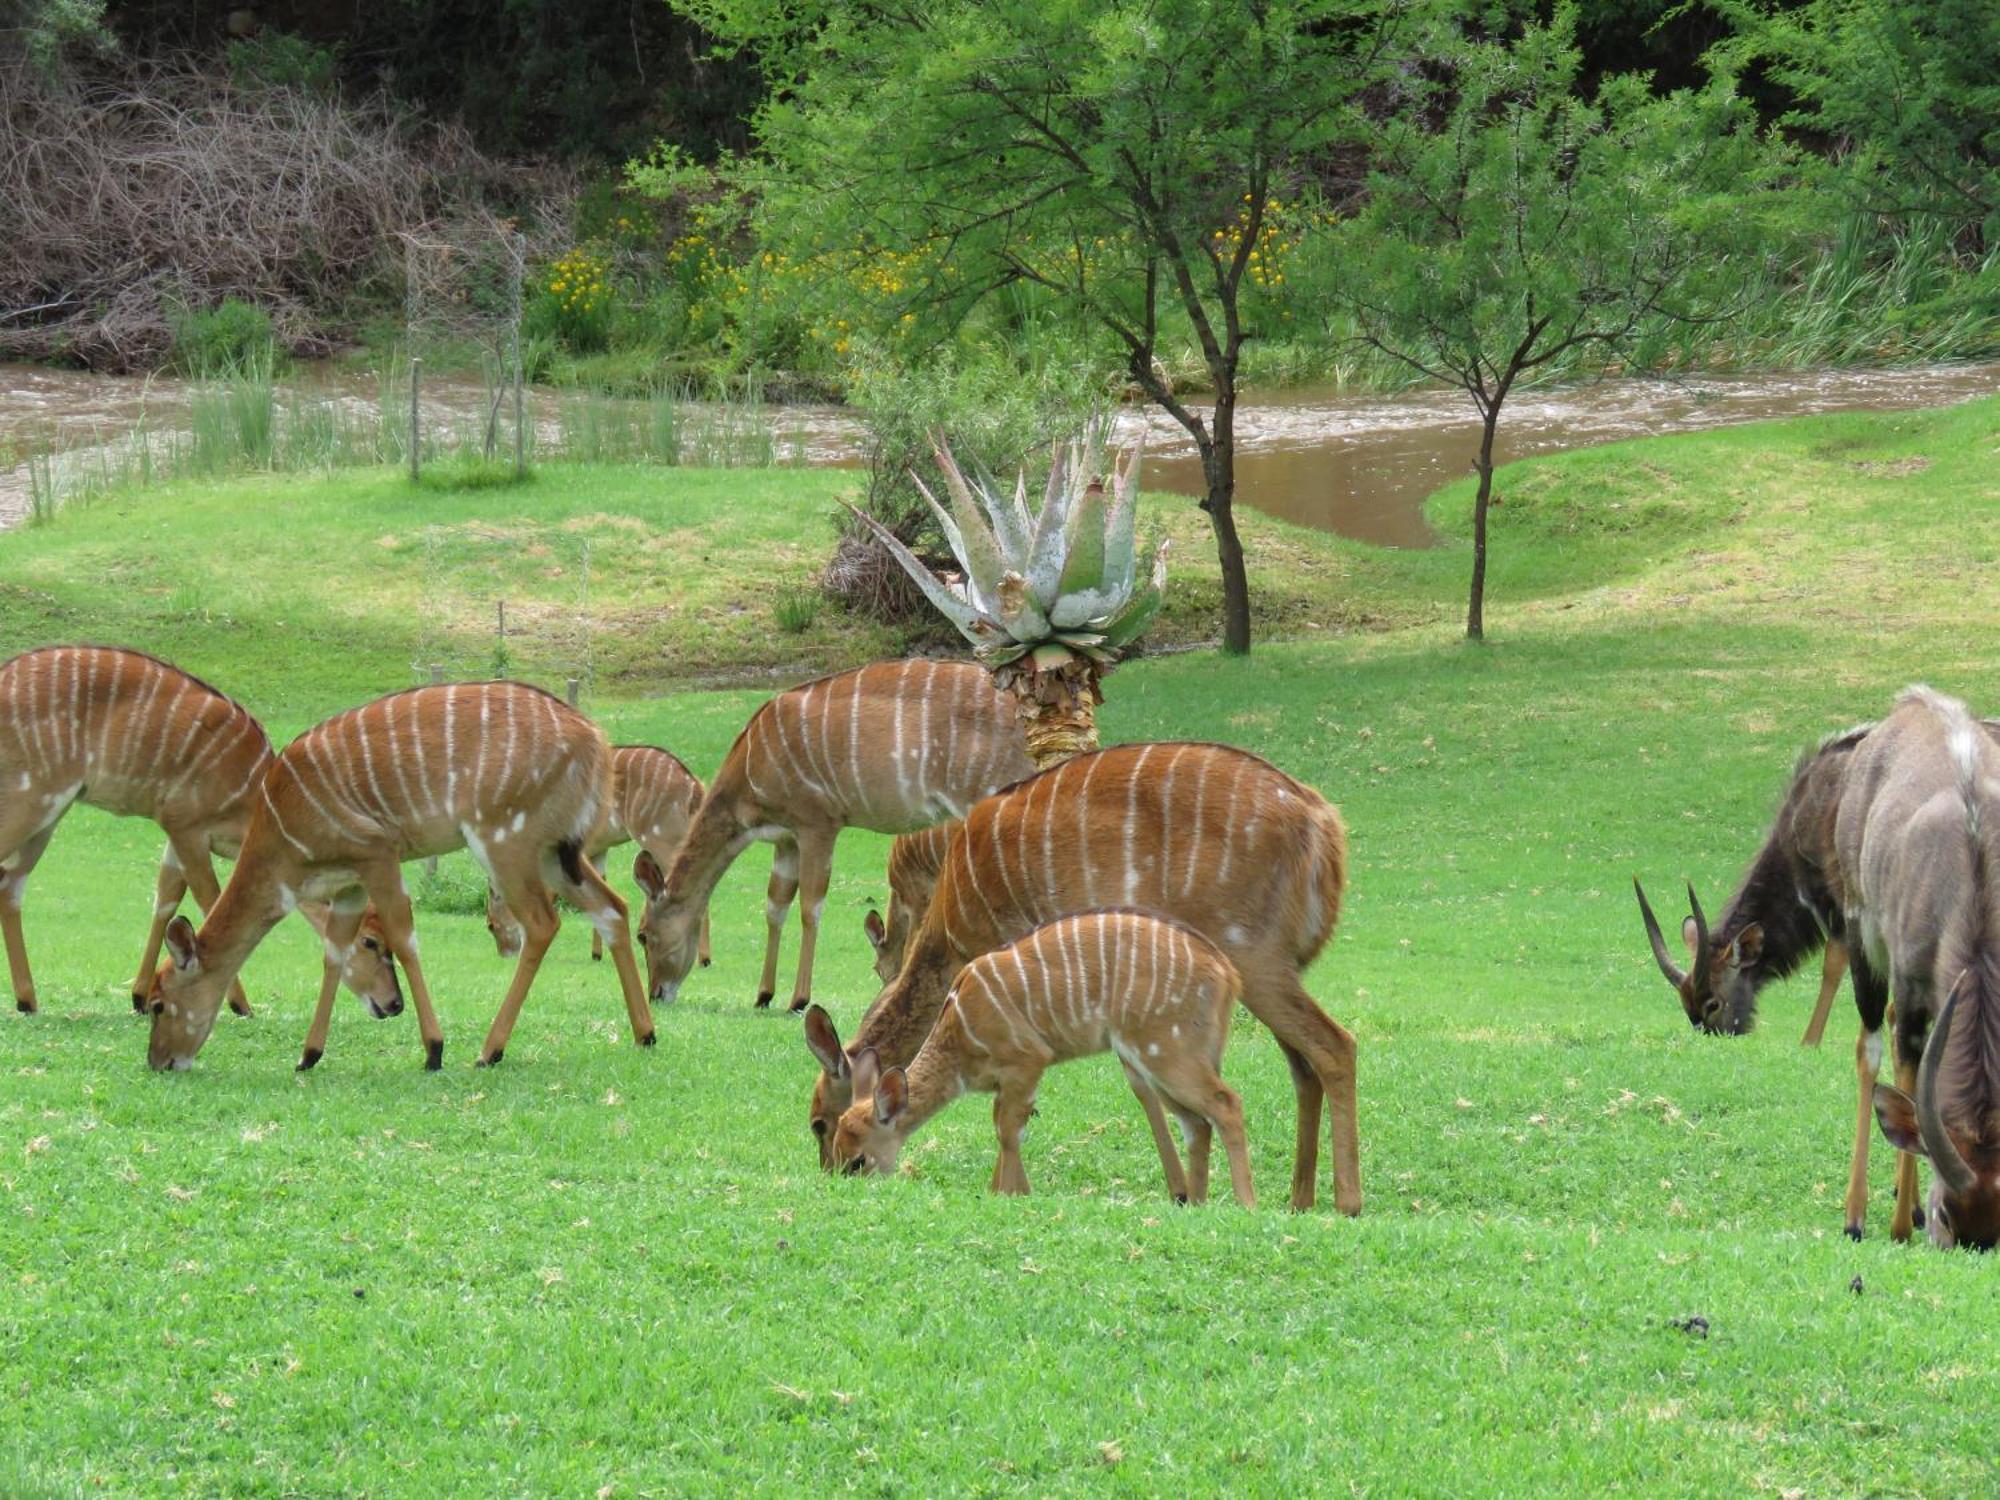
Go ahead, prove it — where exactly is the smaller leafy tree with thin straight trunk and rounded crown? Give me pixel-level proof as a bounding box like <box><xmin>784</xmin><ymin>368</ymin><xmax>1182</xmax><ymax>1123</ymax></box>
<box><xmin>1330</xmin><ymin>6</ymin><xmax>1776</xmax><ymax>640</ymax></box>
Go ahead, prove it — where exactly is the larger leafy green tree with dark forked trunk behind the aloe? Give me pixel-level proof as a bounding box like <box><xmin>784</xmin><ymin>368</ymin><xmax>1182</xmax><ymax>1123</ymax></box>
<box><xmin>674</xmin><ymin>0</ymin><xmax>1422</xmax><ymax>652</ymax></box>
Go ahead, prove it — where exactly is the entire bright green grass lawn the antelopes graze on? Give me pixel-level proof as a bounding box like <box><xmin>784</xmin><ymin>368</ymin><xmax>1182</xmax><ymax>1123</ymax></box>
<box><xmin>0</xmin><ymin>400</ymin><xmax>2000</xmax><ymax>1496</ymax></box>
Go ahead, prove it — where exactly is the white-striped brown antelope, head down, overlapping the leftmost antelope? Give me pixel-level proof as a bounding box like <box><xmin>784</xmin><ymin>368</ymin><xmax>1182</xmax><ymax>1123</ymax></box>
<box><xmin>148</xmin><ymin>682</ymin><xmax>654</xmax><ymax>1070</ymax></box>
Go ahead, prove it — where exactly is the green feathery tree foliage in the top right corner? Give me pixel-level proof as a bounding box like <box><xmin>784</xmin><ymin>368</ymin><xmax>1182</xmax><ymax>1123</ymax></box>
<box><xmin>1712</xmin><ymin>0</ymin><xmax>2000</xmax><ymax>258</ymax></box>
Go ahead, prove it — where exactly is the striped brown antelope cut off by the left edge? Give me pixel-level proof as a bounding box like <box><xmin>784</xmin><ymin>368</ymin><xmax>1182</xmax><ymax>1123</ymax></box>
<box><xmin>0</xmin><ymin>646</ymin><xmax>402</xmax><ymax>1016</ymax></box>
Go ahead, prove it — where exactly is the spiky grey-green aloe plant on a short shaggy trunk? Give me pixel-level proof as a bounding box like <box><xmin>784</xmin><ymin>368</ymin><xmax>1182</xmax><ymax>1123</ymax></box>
<box><xmin>850</xmin><ymin>432</ymin><xmax>1166</xmax><ymax>766</ymax></box>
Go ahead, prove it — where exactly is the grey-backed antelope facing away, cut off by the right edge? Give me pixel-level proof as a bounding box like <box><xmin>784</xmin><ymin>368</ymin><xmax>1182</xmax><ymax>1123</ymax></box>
<box><xmin>1834</xmin><ymin>688</ymin><xmax>2000</xmax><ymax>1250</ymax></box>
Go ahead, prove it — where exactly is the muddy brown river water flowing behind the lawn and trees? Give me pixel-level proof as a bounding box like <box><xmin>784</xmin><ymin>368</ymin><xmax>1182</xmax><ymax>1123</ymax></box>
<box><xmin>0</xmin><ymin>364</ymin><xmax>2000</xmax><ymax>546</ymax></box>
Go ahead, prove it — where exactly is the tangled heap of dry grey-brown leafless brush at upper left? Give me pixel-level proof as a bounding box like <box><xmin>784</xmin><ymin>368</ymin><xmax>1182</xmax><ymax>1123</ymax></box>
<box><xmin>0</xmin><ymin>58</ymin><xmax>536</xmax><ymax>370</ymax></box>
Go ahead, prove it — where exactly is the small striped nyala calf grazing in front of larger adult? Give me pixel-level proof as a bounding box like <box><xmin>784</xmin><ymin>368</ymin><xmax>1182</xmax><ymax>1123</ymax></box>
<box><xmin>832</xmin><ymin>910</ymin><xmax>1256</xmax><ymax>1208</ymax></box>
